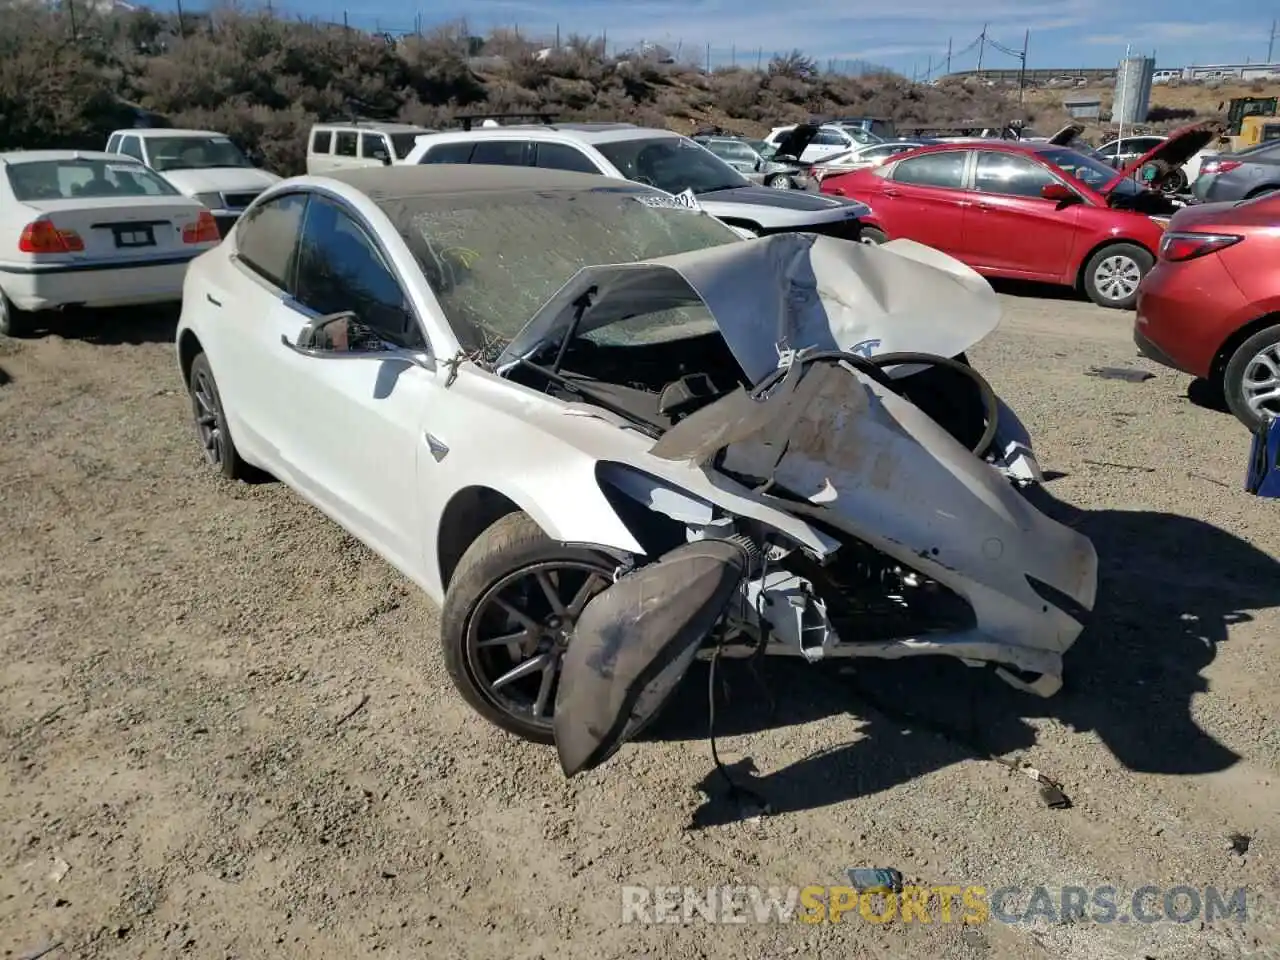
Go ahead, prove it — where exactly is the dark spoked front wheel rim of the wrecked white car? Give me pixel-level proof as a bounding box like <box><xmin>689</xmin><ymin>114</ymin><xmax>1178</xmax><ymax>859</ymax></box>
<box><xmin>466</xmin><ymin>559</ymin><xmax>613</xmax><ymax>731</ymax></box>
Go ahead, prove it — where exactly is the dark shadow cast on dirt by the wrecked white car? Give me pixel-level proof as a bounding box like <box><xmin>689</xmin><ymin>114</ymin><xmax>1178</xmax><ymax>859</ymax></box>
<box><xmin>649</xmin><ymin>490</ymin><xmax>1280</xmax><ymax>827</ymax></box>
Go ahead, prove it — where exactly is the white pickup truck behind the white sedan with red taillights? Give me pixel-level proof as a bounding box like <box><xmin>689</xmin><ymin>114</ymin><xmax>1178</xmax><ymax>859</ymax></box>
<box><xmin>106</xmin><ymin>127</ymin><xmax>280</xmax><ymax>237</ymax></box>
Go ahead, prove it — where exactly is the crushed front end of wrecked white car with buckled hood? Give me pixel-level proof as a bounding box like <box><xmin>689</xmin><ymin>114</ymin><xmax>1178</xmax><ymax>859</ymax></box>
<box><xmin>488</xmin><ymin>234</ymin><xmax>1097</xmax><ymax>774</ymax></box>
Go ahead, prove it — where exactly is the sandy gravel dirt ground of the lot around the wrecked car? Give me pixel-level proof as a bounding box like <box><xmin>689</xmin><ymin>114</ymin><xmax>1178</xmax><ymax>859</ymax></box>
<box><xmin>0</xmin><ymin>292</ymin><xmax>1280</xmax><ymax>960</ymax></box>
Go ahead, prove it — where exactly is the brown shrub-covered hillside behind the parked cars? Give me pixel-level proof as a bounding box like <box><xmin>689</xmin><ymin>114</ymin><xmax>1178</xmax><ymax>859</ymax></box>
<box><xmin>0</xmin><ymin>0</ymin><xmax>1024</xmax><ymax>174</ymax></box>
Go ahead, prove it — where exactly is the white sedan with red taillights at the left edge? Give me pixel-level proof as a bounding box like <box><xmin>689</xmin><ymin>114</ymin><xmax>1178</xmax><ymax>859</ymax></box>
<box><xmin>0</xmin><ymin>150</ymin><xmax>219</xmax><ymax>337</ymax></box>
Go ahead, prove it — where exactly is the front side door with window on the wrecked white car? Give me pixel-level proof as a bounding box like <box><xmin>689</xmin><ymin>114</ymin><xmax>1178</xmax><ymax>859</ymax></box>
<box><xmin>273</xmin><ymin>195</ymin><xmax>443</xmax><ymax>576</ymax></box>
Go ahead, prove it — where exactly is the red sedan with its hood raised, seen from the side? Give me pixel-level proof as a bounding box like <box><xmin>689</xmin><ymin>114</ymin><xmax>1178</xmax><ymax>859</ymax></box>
<box><xmin>822</xmin><ymin>124</ymin><xmax>1215</xmax><ymax>308</ymax></box>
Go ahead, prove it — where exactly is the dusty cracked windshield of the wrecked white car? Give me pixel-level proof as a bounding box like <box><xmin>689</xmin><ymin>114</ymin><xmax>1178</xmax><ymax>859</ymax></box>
<box><xmin>394</xmin><ymin>184</ymin><xmax>740</xmax><ymax>360</ymax></box>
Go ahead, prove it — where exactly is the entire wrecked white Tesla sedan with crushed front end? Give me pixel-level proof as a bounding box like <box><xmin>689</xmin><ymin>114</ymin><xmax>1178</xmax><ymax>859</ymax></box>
<box><xmin>177</xmin><ymin>165</ymin><xmax>1097</xmax><ymax>774</ymax></box>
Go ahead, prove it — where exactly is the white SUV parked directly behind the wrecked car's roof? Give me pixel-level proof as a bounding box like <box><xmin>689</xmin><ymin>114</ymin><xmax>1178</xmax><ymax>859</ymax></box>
<box><xmin>399</xmin><ymin>123</ymin><xmax>868</xmax><ymax>239</ymax></box>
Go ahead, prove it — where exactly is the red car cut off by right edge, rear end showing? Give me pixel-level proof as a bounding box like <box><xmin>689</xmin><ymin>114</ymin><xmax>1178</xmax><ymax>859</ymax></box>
<box><xmin>1133</xmin><ymin>193</ymin><xmax>1280</xmax><ymax>429</ymax></box>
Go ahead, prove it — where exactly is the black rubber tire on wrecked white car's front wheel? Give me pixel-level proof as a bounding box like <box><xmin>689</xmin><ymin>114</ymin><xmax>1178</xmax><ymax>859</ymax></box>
<box><xmin>440</xmin><ymin>512</ymin><xmax>617</xmax><ymax>744</ymax></box>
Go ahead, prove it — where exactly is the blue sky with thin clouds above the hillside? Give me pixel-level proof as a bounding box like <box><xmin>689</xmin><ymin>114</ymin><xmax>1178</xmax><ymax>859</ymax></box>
<box><xmin>165</xmin><ymin>0</ymin><xmax>1280</xmax><ymax>74</ymax></box>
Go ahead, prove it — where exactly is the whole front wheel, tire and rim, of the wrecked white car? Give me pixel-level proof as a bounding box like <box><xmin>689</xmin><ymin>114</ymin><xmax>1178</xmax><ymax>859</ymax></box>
<box><xmin>440</xmin><ymin>512</ymin><xmax>618</xmax><ymax>744</ymax></box>
